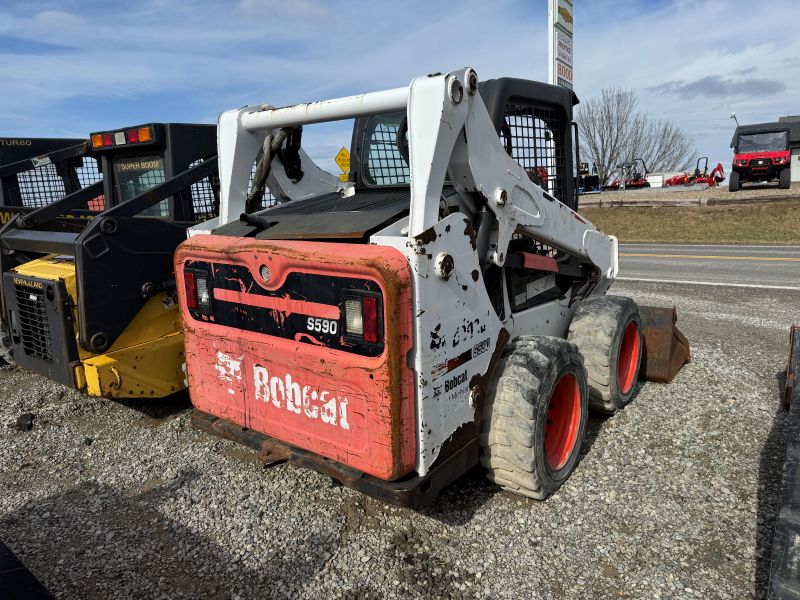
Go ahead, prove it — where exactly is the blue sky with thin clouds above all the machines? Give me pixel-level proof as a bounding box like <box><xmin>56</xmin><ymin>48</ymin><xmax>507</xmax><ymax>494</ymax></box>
<box><xmin>0</xmin><ymin>0</ymin><xmax>800</xmax><ymax>173</ymax></box>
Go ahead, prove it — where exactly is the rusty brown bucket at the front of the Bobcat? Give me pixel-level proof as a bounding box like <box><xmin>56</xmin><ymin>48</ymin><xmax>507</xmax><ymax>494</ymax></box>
<box><xmin>639</xmin><ymin>306</ymin><xmax>691</xmax><ymax>383</ymax></box>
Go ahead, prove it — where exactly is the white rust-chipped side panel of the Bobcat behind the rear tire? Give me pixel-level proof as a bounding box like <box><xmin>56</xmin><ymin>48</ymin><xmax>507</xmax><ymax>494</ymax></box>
<box><xmin>371</xmin><ymin>212</ymin><xmax>506</xmax><ymax>475</ymax></box>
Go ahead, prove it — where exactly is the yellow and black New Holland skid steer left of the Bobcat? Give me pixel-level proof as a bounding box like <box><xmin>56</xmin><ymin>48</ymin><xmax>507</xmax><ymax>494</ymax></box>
<box><xmin>0</xmin><ymin>123</ymin><xmax>218</xmax><ymax>398</ymax></box>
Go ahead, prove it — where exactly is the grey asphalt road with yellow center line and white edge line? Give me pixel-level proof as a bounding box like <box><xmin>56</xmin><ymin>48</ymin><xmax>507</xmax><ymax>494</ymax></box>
<box><xmin>618</xmin><ymin>244</ymin><xmax>800</xmax><ymax>291</ymax></box>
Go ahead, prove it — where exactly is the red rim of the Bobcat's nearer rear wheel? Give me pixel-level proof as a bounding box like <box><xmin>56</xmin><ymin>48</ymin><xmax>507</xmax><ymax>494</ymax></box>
<box><xmin>544</xmin><ymin>373</ymin><xmax>581</xmax><ymax>471</ymax></box>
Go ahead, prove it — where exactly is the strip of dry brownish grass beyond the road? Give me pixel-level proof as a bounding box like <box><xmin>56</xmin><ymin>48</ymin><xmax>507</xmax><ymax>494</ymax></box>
<box><xmin>580</xmin><ymin>200</ymin><xmax>800</xmax><ymax>245</ymax></box>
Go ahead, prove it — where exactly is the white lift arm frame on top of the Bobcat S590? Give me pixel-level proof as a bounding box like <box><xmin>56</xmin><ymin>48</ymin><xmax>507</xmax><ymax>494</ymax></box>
<box><xmin>203</xmin><ymin>68</ymin><xmax>618</xmax><ymax>280</ymax></box>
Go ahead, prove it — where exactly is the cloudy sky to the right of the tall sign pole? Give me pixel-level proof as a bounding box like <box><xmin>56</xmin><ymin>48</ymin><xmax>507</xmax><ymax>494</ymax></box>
<box><xmin>575</xmin><ymin>0</ymin><xmax>800</xmax><ymax>167</ymax></box>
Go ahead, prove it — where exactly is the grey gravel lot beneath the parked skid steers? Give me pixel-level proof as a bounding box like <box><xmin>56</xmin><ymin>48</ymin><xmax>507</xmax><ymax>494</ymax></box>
<box><xmin>0</xmin><ymin>283</ymin><xmax>798</xmax><ymax>599</ymax></box>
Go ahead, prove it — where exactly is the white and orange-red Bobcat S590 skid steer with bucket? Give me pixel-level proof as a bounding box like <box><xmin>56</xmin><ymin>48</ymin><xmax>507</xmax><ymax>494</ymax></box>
<box><xmin>175</xmin><ymin>69</ymin><xmax>688</xmax><ymax>506</ymax></box>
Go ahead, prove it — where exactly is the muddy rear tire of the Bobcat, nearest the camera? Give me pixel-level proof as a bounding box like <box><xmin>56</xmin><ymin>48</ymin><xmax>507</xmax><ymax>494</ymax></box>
<box><xmin>480</xmin><ymin>336</ymin><xmax>589</xmax><ymax>500</ymax></box>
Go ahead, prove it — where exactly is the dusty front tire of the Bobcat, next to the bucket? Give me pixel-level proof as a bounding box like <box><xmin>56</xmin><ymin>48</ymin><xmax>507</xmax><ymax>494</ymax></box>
<box><xmin>567</xmin><ymin>296</ymin><xmax>644</xmax><ymax>415</ymax></box>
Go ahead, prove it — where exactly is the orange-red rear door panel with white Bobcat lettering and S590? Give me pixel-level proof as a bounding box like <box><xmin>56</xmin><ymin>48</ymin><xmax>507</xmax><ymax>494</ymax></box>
<box><xmin>175</xmin><ymin>235</ymin><xmax>416</xmax><ymax>480</ymax></box>
